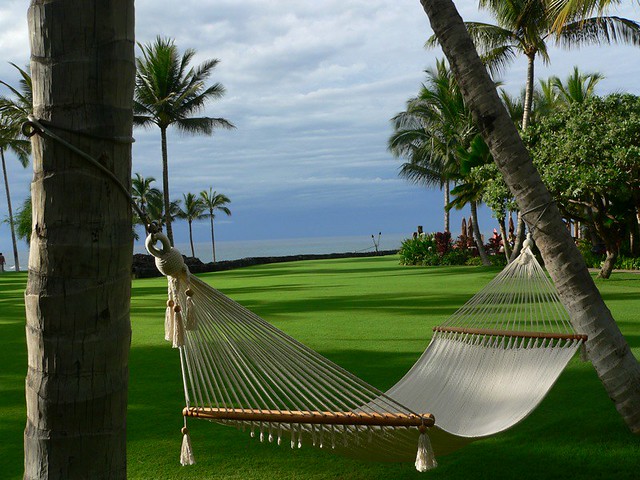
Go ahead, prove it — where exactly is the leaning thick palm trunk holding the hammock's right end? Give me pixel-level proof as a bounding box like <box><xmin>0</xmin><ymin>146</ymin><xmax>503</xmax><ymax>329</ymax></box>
<box><xmin>421</xmin><ymin>0</ymin><xmax>640</xmax><ymax>433</ymax></box>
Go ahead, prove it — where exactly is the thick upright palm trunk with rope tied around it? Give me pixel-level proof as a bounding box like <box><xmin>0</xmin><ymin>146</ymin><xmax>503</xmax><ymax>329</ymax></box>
<box><xmin>24</xmin><ymin>0</ymin><xmax>135</xmax><ymax>479</ymax></box>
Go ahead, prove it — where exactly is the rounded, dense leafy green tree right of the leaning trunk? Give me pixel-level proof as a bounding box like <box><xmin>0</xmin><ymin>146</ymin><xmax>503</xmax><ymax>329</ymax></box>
<box><xmin>528</xmin><ymin>95</ymin><xmax>640</xmax><ymax>278</ymax></box>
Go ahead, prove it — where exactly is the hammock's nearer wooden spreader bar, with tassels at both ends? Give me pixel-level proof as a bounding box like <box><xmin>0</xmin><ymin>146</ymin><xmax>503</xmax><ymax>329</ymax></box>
<box><xmin>182</xmin><ymin>407</ymin><xmax>435</xmax><ymax>427</ymax></box>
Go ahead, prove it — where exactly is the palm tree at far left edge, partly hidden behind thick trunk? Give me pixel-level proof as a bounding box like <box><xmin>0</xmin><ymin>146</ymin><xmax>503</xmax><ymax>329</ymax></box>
<box><xmin>0</xmin><ymin>63</ymin><xmax>33</xmax><ymax>272</ymax></box>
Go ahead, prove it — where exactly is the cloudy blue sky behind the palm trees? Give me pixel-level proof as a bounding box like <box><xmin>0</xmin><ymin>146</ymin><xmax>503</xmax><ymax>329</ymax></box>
<box><xmin>0</xmin><ymin>0</ymin><xmax>640</xmax><ymax>256</ymax></box>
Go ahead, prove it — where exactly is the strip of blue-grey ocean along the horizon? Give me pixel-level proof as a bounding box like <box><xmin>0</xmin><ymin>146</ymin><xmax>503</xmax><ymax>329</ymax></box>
<box><xmin>4</xmin><ymin>233</ymin><xmax>407</xmax><ymax>270</ymax></box>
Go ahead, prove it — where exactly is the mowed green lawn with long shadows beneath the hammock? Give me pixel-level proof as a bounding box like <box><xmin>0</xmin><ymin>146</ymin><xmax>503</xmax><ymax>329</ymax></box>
<box><xmin>0</xmin><ymin>256</ymin><xmax>640</xmax><ymax>480</ymax></box>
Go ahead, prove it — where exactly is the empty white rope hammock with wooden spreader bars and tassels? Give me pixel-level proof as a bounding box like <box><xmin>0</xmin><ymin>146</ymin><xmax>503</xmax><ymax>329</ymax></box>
<box><xmin>146</xmin><ymin>233</ymin><xmax>586</xmax><ymax>471</ymax></box>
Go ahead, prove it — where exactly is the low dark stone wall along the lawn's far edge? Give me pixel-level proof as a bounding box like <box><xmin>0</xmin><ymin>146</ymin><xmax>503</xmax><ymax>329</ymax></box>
<box><xmin>131</xmin><ymin>250</ymin><xmax>398</xmax><ymax>278</ymax></box>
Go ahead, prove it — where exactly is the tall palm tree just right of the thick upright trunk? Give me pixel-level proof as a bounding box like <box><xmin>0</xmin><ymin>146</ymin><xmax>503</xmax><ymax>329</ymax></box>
<box><xmin>133</xmin><ymin>37</ymin><xmax>235</xmax><ymax>244</ymax></box>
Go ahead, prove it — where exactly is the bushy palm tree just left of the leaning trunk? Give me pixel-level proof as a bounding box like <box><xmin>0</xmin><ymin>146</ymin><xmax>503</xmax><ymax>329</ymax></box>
<box><xmin>389</xmin><ymin>59</ymin><xmax>474</xmax><ymax>232</ymax></box>
